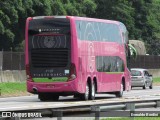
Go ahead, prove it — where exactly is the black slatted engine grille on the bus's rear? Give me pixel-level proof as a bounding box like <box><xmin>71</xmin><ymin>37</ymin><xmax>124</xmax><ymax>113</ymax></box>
<box><xmin>31</xmin><ymin>48</ymin><xmax>69</xmax><ymax>68</ymax></box>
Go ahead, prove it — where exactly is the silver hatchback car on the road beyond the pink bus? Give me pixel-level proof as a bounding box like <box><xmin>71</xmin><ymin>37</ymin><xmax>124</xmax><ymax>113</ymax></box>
<box><xmin>131</xmin><ymin>68</ymin><xmax>153</xmax><ymax>89</ymax></box>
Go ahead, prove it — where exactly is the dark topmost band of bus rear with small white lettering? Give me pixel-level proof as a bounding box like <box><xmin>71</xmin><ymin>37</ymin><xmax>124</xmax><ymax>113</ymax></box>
<box><xmin>28</xmin><ymin>18</ymin><xmax>70</xmax><ymax>35</ymax></box>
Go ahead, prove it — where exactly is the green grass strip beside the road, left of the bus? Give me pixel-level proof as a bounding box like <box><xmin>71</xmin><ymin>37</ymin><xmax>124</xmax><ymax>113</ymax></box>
<box><xmin>0</xmin><ymin>82</ymin><xmax>29</xmax><ymax>97</ymax></box>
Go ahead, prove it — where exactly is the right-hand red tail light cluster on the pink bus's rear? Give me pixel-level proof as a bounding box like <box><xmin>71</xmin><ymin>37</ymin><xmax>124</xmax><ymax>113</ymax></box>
<box><xmin>68</xmin><ymin>63</ymin><xmax>77</xmax><ymax>81</ymax></box>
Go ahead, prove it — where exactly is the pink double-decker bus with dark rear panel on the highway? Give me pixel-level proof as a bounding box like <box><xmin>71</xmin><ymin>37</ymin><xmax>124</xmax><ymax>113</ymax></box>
<box><xmin>25</xmin><ymin>16</ymin><xmax>130</xmax><ymax>101</ymax></box>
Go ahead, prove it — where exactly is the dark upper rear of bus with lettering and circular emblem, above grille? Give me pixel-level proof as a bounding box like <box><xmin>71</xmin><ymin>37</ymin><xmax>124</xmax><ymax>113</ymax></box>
<box><xmin>28</xmin><ymin>19</ymin><xmax>70</xmax><ymax>48</ymax></box>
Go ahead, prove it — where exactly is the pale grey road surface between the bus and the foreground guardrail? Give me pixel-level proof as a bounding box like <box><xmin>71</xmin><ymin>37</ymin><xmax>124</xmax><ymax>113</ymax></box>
<box><xmin>0</xmin><ymin>86</ymin><xmax>160</xmax><ymax>111</ymax></box>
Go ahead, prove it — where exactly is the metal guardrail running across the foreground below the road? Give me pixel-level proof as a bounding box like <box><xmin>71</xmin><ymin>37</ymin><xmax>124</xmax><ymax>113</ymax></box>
<box><xmin>0</xmin><ymin>98</ymin><xmax>160</xmax><ymax>120</ymax></box>
